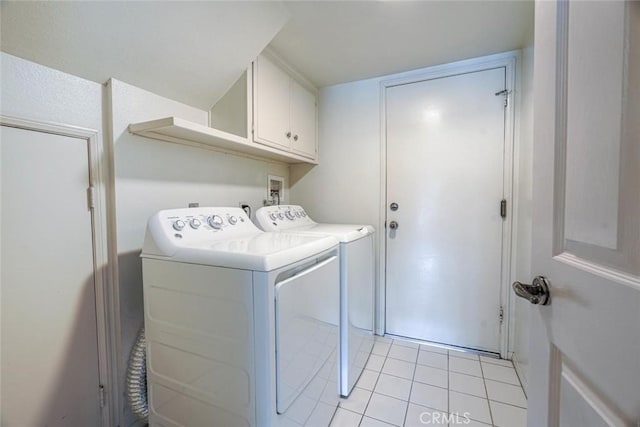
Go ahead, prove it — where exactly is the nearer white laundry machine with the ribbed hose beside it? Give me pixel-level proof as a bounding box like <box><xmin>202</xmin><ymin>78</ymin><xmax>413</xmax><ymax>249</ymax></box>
<box><xmin>141</xmin><ymin>208</ymin><xmax>340</xmax><ymax>427</ymax></box>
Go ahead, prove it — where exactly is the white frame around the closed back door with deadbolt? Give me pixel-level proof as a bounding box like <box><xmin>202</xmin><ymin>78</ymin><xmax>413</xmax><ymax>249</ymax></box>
<box><xmin>376</xmin><ymin>51</ymin><xmax>521</xmax><ymax>359</ymax></box>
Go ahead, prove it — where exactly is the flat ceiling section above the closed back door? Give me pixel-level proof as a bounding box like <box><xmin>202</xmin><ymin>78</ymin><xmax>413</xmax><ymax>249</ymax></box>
<box><xmin>271</xmin><ymin>0</ymin><xmax>534</xmax><ymax>87</ymax></box>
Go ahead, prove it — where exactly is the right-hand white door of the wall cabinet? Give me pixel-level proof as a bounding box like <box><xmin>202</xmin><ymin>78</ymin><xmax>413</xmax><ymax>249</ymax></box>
<box><xmin>291</xmin><ymin>80</ymin><xmax>317</xmax><ymax>159</ymax></box>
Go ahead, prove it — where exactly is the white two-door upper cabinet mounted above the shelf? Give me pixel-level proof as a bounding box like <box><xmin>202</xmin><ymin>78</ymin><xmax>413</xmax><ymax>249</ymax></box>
<box><xmin>253</xmin><ymin>55</ymin><xmax>317</xmax><ymax>160</ymax></box>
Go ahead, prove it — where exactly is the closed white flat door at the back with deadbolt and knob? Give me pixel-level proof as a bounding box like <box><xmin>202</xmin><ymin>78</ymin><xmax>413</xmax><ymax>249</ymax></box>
<box><xmin>385</xmin><ymin>67</ymin><xmax>506</xmax><ymax>353</ymax></box>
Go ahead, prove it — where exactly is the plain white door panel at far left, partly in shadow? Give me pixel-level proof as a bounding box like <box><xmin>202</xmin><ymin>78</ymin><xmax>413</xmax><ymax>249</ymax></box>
<box><xmin>0</xmin><ymin>126</ymin><xmax>101</xmax><ymax>427</ymax></box>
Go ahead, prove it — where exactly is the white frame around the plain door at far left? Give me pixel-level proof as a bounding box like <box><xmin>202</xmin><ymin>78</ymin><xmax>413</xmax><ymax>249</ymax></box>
<box><xmin>0</xmin><ymin>115</ymin><xmax>119</xmax><ymax>426</ymax></box>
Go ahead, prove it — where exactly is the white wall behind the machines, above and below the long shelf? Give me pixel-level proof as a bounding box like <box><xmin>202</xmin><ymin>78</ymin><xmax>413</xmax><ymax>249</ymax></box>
<box><xmin>110</xmin><ymin>80</ymin><xmax>289</xmax><ymax>426</ymax></box>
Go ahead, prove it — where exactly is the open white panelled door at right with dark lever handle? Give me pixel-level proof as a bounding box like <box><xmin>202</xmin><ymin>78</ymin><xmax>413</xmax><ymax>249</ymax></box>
<box><xmin>528</xmin><ymin>1</ymin><xmax>640</xmax><ymax>427</ymax></box>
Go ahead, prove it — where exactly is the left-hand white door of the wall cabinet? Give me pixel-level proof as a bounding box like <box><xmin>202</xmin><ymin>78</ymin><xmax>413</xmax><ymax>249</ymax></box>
<box><xmin>253</xmin><ymin>56</ymin><xmax>291</xmax><ymax>149</ymax></box>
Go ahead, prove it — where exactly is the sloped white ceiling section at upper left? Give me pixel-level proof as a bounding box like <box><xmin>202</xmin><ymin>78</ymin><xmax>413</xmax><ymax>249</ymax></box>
<box><xmin>0</xmin><ymin>0</ymin><xmax>289</xmax><ymax>110</ymax></box>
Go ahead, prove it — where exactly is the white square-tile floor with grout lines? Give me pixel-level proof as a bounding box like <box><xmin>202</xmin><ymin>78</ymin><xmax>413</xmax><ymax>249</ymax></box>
<box><xmin>331</xmin><ymin>337</ymin><xmax>527</xmax><ymax>427</ymax></box>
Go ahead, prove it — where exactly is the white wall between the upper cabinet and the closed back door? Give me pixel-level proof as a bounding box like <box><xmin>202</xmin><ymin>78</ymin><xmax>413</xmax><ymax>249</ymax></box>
<box><xmin>291</xmin><ymin>79</ymin><xmax>380</xmax><ymax>227</ymax></box>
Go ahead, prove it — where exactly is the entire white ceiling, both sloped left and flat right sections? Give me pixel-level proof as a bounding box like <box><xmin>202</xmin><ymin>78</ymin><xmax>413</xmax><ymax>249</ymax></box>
<box><xmin>0</xmin><ymin>0</ymin><xmax>533</xmax><ymax>109</ymax></box>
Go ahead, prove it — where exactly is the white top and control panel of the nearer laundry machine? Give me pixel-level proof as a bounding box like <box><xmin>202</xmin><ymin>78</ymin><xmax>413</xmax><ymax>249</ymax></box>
<box><xmin>141</xmin><ymin>208</ymin><xmax>338</xmax><ymax>271</ymax></box>
